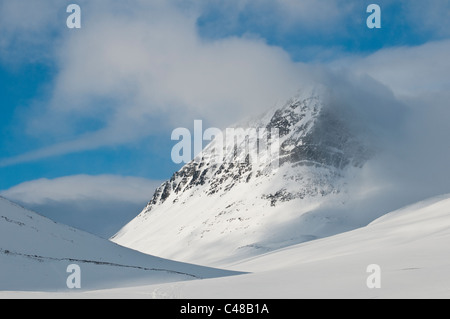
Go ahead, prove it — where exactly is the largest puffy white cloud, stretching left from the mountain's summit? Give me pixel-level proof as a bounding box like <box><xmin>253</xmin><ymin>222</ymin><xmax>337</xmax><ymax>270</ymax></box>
<box><xmin>0</xmin><ymin>1</ymin><xmax>305</xmax><ymax>166</ymax></box>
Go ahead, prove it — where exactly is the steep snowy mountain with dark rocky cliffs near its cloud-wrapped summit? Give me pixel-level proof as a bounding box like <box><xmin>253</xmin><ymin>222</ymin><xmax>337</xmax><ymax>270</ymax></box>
<box><xmin>111</xmin><ymin>87</ymin><xmax>373</xmax><ymax>264</ymax></box>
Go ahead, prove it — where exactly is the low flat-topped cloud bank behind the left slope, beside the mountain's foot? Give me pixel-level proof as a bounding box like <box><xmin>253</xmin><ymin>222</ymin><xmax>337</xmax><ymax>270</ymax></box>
<box><xmin>0</xmin><ymin>175</ymin><xmax>161</xmax><ymax>238</ymax></box>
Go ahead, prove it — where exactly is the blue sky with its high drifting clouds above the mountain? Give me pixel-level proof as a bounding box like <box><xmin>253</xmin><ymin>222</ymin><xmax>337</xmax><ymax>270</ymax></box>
<box><xmin>0</xmin><ymin>0</ymin><xmax>450</xmax><ymax>232</ymax></box>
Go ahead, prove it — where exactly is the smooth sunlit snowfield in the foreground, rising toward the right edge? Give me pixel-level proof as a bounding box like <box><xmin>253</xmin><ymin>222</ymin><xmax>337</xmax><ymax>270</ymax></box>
<box><xmin>0</xmin><ymin>195</ymin><xmax>450</xmax><ymax>298</ymax></box>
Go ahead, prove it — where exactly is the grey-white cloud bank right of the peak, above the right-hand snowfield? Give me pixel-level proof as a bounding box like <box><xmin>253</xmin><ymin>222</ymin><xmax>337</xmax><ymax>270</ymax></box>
<box><xmin>327</xmin><ymin>40</ymin><xmax>450</xmax><ymax>207</ymax></box>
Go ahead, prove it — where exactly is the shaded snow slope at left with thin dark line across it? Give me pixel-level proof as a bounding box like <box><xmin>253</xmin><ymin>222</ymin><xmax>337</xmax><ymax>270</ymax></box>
<box><xmin>0</xmin><ymin>197</ymin><xmax>239</xmax><ymax>291</ymax></box>
